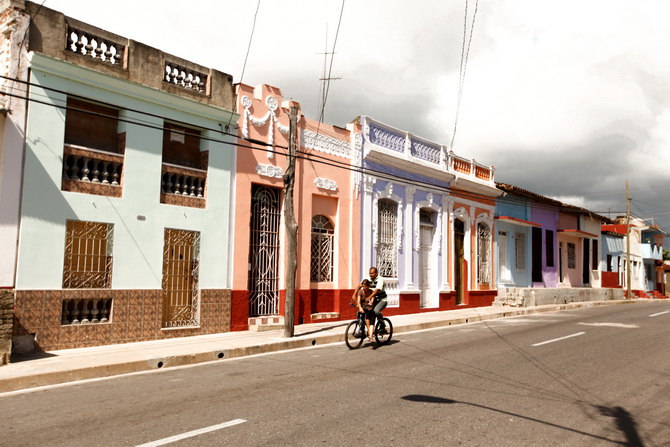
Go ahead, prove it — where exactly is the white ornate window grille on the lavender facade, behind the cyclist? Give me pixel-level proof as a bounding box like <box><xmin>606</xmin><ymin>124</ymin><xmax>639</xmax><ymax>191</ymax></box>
<box><xmin>377</xmin><ymin>200</ymin><xmax>398</xmax><ymax>278</ymax></box>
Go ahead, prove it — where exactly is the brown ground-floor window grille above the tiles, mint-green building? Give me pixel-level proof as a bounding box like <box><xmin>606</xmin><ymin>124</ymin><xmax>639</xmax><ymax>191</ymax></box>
<box><xmin>63</xmin><ymin>220</ymin><xmax>114</xmax><ymax>289</ymax></box>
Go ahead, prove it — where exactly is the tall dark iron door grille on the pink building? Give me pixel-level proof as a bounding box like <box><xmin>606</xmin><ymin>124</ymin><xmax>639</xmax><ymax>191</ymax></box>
<box><xmin>249</xmin><ymin>185</ymin><xmax>280</xmax><ymax>317</ymax></box>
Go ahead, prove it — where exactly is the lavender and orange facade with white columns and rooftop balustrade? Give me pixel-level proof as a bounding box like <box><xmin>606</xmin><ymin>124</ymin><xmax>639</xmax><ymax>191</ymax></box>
<box><xmin>351</xmin><ymin>116</ymin><xmax>500</xmax><ymax>315</ymax></box>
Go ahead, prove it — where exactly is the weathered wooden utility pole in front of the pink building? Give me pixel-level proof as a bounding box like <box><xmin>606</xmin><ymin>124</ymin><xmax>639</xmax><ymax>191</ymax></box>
<box><xmin>284</xmin><ymin>105</ymin><xmax>298</xmax><ymax>338</ymax></box>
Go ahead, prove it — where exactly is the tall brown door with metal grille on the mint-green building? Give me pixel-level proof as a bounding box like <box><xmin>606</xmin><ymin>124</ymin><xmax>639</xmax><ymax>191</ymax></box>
<box><xmin>162</xmin><ymin>228</ymin><xmax>200</xmax><ymax>328</ymax></box>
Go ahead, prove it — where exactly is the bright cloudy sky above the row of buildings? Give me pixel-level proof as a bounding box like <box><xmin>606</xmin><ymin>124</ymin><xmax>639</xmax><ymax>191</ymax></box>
<box><xmin>44</xmin><ymin>0</ymin><xmax>670</xmax><ymax>243</ymax></box>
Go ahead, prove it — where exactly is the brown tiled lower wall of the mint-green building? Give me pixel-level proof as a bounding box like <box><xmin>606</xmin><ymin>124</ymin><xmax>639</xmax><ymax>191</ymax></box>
<box><xmin>14</xmin><ymin>289</ymin><xmax>231</xmax><ymax>351</ymax></box>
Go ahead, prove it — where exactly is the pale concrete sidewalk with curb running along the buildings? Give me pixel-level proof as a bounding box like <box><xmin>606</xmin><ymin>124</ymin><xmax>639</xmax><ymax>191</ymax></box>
<box><xmin>0</xmin><ymin>299</ymin><xmax>653</xmax><ymax>393</ymax></box>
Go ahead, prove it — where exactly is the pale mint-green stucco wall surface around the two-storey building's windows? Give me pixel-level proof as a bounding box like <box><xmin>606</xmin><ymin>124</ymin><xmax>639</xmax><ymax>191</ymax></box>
<box><xmin>17</xmin><ymin>56</ymin><xmax>233</xmax><ymax>289</ymax></box>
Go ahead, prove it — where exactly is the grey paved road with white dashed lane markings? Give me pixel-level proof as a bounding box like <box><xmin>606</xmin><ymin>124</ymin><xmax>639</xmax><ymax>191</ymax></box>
<box><xmin>0</xmin><ymin>302</ymin><xmax>670</xmax><ymax>446</ymax></box>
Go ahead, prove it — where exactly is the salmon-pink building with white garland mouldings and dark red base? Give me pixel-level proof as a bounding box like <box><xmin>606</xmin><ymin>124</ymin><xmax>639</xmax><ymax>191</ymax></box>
<box><xmin>231</xmin><ymin>84</ymin><xmax>360</xmax><ymax>330</ymax></box>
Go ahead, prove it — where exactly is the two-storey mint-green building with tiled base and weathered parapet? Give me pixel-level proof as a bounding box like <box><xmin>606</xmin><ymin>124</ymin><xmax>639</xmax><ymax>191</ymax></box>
<box><xmin>3</xmin><ymin>2</ymin><xmax>237</xmax><ymax>350</ymax></box>
